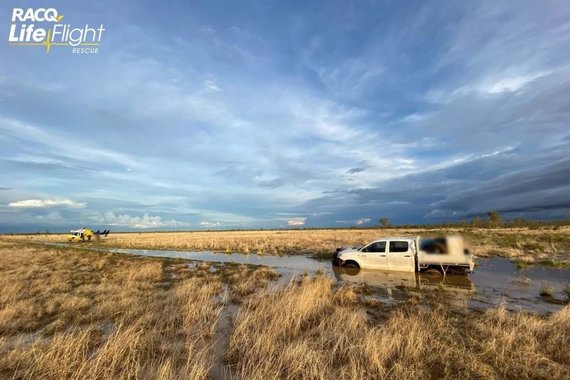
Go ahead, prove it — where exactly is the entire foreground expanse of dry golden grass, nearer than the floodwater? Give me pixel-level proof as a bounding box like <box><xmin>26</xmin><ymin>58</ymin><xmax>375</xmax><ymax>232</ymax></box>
<box><xmin>0</xmin><ymin>242</ymin><xmax>570</xmax><ymax>379</ymax></box>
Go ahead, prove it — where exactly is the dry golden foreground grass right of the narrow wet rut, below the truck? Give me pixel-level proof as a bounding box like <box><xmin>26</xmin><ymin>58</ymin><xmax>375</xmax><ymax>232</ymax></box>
<box><xmin>228</xmin><ymin>276</ymin><xmax>570</xmax><ymax>379</ymax></box>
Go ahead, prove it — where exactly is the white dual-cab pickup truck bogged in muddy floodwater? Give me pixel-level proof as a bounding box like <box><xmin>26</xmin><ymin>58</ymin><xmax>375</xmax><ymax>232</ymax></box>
<box><xmin>333</xmin><ymin>235</ymin><xmax>475</xmax><ymax>274</ymax></box>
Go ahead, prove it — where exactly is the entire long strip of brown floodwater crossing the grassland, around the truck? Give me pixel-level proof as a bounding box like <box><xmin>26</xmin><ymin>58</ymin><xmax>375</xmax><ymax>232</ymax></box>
<box><xmin>52</xmin><ymin>244</ymin><xmax>570</xmax><ymax>313</ymax></box>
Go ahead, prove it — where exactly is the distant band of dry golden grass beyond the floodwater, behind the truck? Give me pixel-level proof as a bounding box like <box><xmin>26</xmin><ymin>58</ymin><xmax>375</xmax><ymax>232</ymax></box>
<box><xmin>0</xmin><ymin>227</ymin><xmax>570</xmax><ymax>258</ymax></box>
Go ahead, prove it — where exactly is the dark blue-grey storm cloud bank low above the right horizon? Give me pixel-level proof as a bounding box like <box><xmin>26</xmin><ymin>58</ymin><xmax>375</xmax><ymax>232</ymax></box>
<box><xmin>303</xmin><ymin>152</ymin><xmax>570</xmax><ymax>223</ymax></box>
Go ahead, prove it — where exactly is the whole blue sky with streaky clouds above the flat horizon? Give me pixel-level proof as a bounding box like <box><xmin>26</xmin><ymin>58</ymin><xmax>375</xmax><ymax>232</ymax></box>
<box><xmin>0</xmin><ymin>0</ymin><xmax>570</xmax><ymax>232</ymax></box>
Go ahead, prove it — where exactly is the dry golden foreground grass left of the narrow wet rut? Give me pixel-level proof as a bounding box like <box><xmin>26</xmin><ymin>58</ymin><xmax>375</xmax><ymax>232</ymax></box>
<box><xmin>0</xmin><ymin>243</ymin><xmax>276</xmax><ymax>379</ymax></box>
